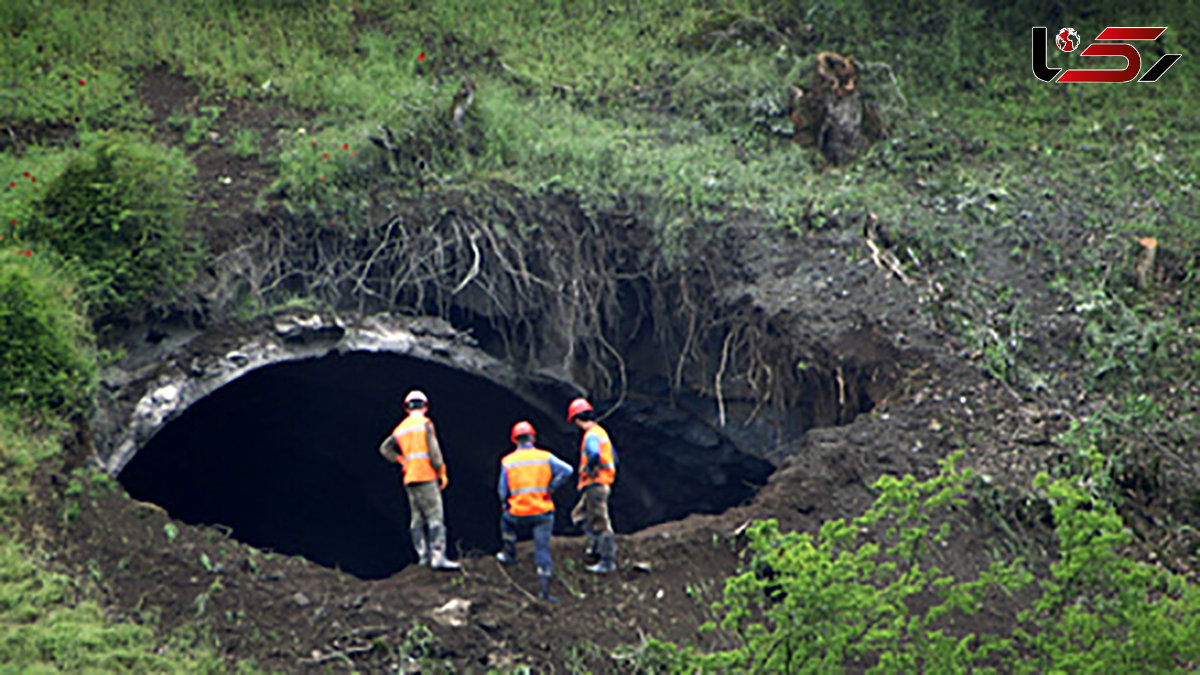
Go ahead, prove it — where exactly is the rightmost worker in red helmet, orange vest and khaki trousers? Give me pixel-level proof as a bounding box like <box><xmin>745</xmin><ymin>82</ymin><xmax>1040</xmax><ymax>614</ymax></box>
<box><xmin>566</xmin><ymin>399</ymin><xmax>617</xmax><ymax>574</ymax></box>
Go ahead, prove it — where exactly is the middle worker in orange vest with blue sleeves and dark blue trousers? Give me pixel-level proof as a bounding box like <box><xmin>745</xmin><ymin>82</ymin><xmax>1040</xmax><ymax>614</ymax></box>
<box><xmin>496</xmin><ymin>420</ymin><xmax>575</xmax><ymax>602</ymax></box>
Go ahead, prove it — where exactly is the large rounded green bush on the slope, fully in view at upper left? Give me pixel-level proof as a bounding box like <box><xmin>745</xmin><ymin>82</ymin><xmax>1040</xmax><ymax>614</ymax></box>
<box><xmin>29</xmin><ymin>136</ymin><xmax>199</xmax><ymax>322</ymax></box>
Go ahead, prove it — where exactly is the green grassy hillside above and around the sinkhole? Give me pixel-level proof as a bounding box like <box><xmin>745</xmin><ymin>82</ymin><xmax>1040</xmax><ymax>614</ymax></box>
<box><xmin>0</xmin><ymin>0</ymin><xmax>1200</xmax><ymax>670</ymax></box>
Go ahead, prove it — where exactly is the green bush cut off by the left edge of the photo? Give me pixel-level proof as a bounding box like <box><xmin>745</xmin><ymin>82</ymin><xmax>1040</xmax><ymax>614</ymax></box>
<box><xmin>0</xmin><ymin>251</ymin><xmax>96</xmax><ymax>412</ymax></box>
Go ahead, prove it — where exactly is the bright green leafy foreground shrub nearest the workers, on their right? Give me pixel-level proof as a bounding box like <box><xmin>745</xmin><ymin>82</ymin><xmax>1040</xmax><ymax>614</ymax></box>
<box><xmin>686</xmin><ymin>449</ymin><xmax>1030</xmax><ymax>673</ymax></box>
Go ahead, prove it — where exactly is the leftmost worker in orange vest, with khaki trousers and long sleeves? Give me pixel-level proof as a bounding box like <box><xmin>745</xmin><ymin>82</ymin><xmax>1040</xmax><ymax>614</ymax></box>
<box><xmin>379</xmin><ymin>389</ymin><xmax>460</xmax><ymax>569</ymax></box>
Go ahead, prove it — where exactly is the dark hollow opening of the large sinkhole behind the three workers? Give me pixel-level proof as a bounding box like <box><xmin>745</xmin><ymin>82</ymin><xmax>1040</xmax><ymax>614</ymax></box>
<box><xmin>120</xmin><ymin>352</ymin><xmax>772</xmax><ymax>578</ymax></box>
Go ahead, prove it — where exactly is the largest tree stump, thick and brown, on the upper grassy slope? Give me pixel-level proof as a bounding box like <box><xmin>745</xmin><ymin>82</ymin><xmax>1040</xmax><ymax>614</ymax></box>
<box><xmin>791</xmin><ymin>52</ymin><xmax>884</xmax><ymax>165</ymax></box>
